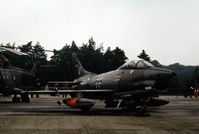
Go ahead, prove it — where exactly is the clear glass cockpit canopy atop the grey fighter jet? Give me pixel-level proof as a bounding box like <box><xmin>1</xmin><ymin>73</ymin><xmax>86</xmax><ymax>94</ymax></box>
<box><xmin>118</xmin><ymin>60</ymin><xmax>154</xmax><ymax>69</ymax></box>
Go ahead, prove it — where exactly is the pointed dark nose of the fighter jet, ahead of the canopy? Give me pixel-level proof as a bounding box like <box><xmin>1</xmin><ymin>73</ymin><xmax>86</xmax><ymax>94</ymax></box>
<box><xmin>145</xmin><ymin>67</ymin><xmax>176</xmax><ymax>80</ymax></box>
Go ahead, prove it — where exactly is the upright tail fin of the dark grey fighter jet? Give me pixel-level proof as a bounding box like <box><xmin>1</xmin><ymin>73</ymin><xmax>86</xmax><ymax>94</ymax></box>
<box><xmin>72</xmin><ymin>53</ymin><xmax>90</xmax><ymax>77</ymax></box>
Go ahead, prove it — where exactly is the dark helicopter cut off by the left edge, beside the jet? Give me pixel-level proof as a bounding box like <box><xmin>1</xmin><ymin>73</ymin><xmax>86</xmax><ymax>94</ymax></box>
<box><xmin>0</xmin><ymin>47</ymin><xmax>38</xmax><ymax>102</ymax></box>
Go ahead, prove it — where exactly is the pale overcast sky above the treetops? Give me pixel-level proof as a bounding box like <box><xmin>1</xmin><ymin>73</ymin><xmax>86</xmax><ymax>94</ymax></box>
<box><xmin>0</xmin><ymin>0</ymin><xmax>199</xmax><ymax>65</ymax></box>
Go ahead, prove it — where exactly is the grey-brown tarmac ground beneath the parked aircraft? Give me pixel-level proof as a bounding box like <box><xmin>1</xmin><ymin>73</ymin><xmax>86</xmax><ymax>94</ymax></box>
<box><xmin>0</xmin><ymin>96</ymin><xmax>199</xmax><ymax>134</ymax></box>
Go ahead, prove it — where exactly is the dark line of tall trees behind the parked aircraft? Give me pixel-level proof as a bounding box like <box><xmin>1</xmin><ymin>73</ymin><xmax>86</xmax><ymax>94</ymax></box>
<box><xmin>0</xmin><ymin>37</ymin><xmax>199</xmax><ymax>94</ymax></box>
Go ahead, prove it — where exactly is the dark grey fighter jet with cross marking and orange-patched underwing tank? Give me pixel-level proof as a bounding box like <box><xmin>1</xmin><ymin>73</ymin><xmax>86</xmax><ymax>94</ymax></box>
<box><xmin>30</xmin><ymin>53</ymin><xmax>175</xmax><ymax>112</ymax></box>
